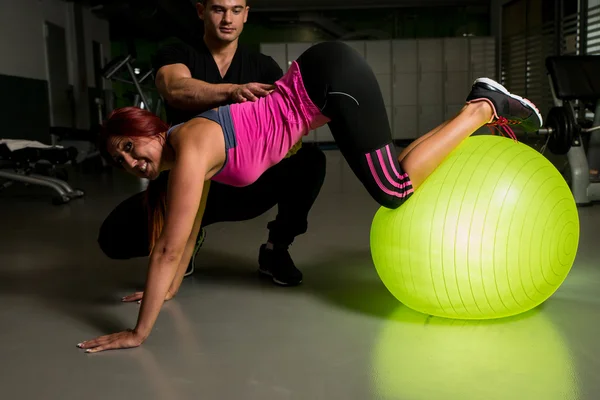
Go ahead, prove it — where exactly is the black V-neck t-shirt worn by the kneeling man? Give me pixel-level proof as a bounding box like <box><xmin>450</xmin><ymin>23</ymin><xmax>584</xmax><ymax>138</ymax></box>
<box><xmin>153</xmin><ymin>41</ymin><xmax>283</xmax><ymax>125</ymax></box>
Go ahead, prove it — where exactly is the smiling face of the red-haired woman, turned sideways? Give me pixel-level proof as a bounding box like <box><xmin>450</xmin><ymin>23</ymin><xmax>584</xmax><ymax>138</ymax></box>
<box><xmin>108</xmin><ymin>136</ymin><xmax>164</xmax><ymax>180</ymax></box>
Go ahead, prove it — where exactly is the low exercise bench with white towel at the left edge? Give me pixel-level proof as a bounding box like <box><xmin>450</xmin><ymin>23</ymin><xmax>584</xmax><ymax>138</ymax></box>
<box><xmin>0</xmin><ymin>140</ymin><xmax>84</xmax><ymax>205</ymax></box>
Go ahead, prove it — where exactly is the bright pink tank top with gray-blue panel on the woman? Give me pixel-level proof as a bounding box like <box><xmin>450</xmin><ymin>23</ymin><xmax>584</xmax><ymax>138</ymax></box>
<box><xmin>212</xmin><ymin>62</ymin><xmax>330</xmax><ymax>186</ymax></box>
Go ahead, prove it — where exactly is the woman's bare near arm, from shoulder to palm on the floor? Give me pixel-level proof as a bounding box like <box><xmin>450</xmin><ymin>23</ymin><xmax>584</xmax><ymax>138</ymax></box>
<box><xmin>78</xmin><ymin>123</ymin><xmax>225</xmax><ymax>352</ymax></box>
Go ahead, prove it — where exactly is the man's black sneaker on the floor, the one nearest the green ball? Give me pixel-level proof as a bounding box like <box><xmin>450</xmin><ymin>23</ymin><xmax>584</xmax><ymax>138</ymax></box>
<box><xmin>258</xmin><ymin>244</ymin><xmax>302</xmax><ymax>286</ymax></box>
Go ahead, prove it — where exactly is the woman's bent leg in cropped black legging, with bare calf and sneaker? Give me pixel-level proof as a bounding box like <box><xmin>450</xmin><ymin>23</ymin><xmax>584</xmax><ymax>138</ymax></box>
<box><xmin>297</xmin><ymin>42</ymin><xmax>542</xmax><ymax>208</ymax></box>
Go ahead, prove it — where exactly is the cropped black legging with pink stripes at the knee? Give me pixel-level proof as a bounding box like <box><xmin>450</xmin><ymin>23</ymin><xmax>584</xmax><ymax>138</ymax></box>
<box><xmin>297</xmin><ymin>42</ymin><xmax>413</xmax><ymax>208</ymax></box>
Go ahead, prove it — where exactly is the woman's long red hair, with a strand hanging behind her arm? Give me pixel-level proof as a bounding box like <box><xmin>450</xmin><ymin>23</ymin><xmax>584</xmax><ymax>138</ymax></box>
<box><xmin>98</xmin><ymin>107</ymin><xmax>169</xmax><ymax>252</ymax></box>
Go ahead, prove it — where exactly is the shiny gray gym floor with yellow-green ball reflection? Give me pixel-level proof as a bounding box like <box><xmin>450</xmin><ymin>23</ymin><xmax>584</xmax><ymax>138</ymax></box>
<box><xmin>0</xmin><ymin>151</ymin><xmax>600</xmax><ymax>400</ymax></box>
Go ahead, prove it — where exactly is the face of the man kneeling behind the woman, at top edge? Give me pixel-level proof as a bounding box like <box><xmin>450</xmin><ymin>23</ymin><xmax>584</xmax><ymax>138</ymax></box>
<box><xmin>196</xmin><ymin>0</ymin><xmax>250</xmax><ymax>42</ymax></box>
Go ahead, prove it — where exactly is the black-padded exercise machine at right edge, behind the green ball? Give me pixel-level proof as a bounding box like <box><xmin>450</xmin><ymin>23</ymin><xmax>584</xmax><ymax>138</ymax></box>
<box><xmin>524</xmin><ymin>56</ymin><xmax>600</xmax><ymax>206</ymax></box>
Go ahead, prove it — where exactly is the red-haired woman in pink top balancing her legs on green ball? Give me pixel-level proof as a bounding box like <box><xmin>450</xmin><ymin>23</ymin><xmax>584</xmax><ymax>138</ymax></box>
<box><xmin>78</xmin><ymin>42</ymin><xmax>542</xmax><ymax>352</ymax></box>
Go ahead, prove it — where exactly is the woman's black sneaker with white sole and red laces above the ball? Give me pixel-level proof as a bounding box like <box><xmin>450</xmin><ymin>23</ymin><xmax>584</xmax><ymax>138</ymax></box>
<box><xmin>467</xmin><ymin>78</ymin><xmax>543</xmax><ymax>140</ymax></box>
